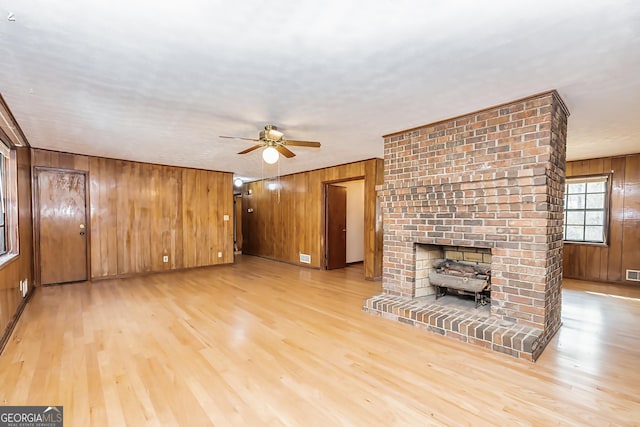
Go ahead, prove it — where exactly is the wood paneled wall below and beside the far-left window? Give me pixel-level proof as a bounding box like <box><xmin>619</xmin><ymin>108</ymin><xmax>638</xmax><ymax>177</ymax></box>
<box><xmin>0</xmin><ymin>148</ymin><xmax>33</xmax><ymax>350</ymax></box>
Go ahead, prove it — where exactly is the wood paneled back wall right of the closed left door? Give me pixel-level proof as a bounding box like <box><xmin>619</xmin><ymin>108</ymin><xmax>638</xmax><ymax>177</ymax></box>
<box><xmin>33</xmin><ymin>150</ymin><xmax>234</xmax><ymax>278</ymax></box>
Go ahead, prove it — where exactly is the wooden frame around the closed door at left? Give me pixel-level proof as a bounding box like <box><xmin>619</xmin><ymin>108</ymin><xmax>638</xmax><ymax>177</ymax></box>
<box><xmin>31</xmin><ymin>166</ymin><xmax>91</xmax><ymax>286</ymax></box>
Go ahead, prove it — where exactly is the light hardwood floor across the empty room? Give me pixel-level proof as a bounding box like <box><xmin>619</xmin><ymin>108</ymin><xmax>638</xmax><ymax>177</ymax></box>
<box><xmin>0</xmin><ymin>256</ymin><xmax>640</xmax><ymax>426</ymax></box>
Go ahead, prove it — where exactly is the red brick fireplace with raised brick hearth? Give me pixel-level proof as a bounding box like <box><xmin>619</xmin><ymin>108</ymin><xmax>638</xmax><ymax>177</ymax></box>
<box><xmin>364</xmin><ymin>91</ymin><xmax>569</xmax><ymax>361</ymax></box>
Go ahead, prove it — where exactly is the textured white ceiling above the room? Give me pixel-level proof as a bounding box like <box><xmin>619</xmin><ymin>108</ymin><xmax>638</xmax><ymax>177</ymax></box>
<box><xmin>0</xmin><ymin>0</ymin><xmax>640</xmax><ymax>178</ymax></box>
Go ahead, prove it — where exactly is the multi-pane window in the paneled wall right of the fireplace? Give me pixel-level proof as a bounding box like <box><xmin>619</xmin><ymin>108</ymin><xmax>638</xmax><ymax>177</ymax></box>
<box><xmin>564</xmin><ymin>176</ymin><xmax>609</xmax><ymax>243</ymax></box>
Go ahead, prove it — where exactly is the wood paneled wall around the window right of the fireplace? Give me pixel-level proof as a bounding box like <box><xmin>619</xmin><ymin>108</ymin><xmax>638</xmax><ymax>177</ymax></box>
<box><xmin>563</xmin><ymin>154</ymin><xmax>640</xmax><ymax>284</ymax></box>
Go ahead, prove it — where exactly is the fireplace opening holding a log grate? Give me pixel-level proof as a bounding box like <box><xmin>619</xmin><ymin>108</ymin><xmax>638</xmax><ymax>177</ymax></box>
<box><xmin>415</xmin><ymin>244</ymin><xmax>491</xmax><ymax>309</ymax></box>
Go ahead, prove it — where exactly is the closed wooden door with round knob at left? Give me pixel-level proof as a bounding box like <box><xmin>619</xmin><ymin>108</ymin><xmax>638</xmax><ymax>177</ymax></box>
<box><xmin>37</xmin><ymin>170</ymin><xmax>87</xmax><ymax>285</ymax></box>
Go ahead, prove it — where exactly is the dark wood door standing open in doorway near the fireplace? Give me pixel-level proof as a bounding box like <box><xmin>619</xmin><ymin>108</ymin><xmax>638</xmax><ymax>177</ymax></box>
<box><xmin>327</xmin><ymin>185</ymin><xmax>347</xmax><ymax>270</ymax></box>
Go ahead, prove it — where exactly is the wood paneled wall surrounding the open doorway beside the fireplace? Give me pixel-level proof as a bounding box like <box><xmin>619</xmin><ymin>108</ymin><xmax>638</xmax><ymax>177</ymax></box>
<box><xmin>242</xmin><ymin>159</ymin><xmax>384</xmax><ymax>279</ymax></box>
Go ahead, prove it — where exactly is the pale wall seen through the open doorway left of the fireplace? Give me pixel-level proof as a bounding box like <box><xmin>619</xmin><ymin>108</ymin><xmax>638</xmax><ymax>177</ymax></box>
<box><xmin>338</xmin><ymin>179</ymin><xmax>364</xmax><ymax>263</ymax></box>
